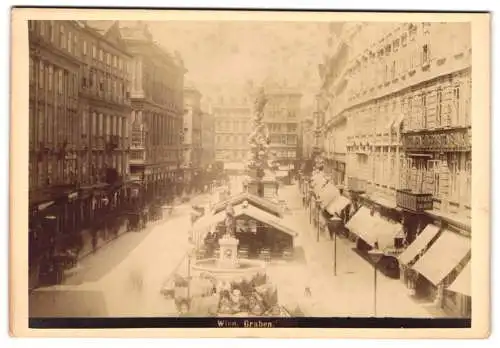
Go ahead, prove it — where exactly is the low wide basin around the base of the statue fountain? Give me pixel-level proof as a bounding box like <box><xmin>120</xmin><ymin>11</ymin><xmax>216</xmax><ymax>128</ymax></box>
<box><xmin>191</xmin><ymin>258</ymin><xmax>266</xmax><ymax>280</ymax></box>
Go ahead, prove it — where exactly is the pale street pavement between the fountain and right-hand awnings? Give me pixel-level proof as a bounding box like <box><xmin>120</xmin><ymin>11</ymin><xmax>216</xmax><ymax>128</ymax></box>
<box><xmin>280</xmin><ymin>185</ymin><xmax>446</xmax><ymax>318</ymax></box>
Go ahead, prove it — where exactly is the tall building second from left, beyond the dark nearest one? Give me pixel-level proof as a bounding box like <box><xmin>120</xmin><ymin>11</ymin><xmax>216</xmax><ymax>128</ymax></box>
<box><xmin>120</xmin><ymin>21</ymin><xmax>186</xmax><ymax>200</ymax></box>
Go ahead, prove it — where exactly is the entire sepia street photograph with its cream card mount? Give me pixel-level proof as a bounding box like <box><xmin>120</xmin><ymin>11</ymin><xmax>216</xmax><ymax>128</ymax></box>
<box><xmin>7</xmin><ymin>9</ymin><xmax>490</xmax><ymax>338</ymax></box>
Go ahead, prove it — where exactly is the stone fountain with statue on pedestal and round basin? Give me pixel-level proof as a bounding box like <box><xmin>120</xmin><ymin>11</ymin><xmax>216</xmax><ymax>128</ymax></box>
<box><xmin>191</xmin><ymin>202</ymin><xmax>266</xmax><ymax>281</ymax></box>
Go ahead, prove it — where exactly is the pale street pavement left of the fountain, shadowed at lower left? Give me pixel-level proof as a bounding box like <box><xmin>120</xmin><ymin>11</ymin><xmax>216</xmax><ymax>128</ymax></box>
<box><xmin>30</xmin><ymin>195</ymin><xmax>213</xmax><ymax>317</ymax></box>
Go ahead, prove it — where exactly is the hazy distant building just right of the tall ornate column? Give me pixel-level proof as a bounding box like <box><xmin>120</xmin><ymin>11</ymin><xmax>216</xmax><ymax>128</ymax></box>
<box><xmin>264</xmin><ymin>85</ymin><xmax>302</xmax><ymax>170</ymax></box>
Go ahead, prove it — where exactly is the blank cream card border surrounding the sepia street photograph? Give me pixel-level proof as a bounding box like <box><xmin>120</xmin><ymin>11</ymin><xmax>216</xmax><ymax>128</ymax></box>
<box><xmin>10</xmin><ymin>9</ymin><xmax>490</xmax><ymax>338</ymax></box>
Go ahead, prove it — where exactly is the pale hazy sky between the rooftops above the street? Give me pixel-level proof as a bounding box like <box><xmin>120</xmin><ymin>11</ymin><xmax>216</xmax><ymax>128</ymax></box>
<box><xmin>148</xmin><ymin>21</ymin><xmax>328</xmax><ymax>104</ymax></box>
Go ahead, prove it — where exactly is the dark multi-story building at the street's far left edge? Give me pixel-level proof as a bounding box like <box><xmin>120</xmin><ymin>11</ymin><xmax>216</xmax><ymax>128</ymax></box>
<box><xmin>29</xmin><ymin>21</ymin><xmax>130</xmax><ymax>290</ymax></box>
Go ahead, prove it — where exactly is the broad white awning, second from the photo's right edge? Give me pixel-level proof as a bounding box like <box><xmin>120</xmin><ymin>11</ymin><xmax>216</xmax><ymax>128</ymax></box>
<box><xmin>413</xmin><ymin>230</ymin><xmax>471</xmax><ymax>285</ymax></box>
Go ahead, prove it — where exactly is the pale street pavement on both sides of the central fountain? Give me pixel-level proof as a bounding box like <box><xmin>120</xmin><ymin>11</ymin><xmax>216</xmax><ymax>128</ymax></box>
<box><xmin>29</xmin><ymin>185</ymin><xmax>444</xmax><ymax>317</ymax></box>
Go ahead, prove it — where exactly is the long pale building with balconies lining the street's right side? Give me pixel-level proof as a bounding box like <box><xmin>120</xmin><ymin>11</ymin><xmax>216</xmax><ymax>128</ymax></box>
<box><xmin>320</xmin><ymin>23</ymin><xmax>472</xmax><ymax>315</ymax></box>
